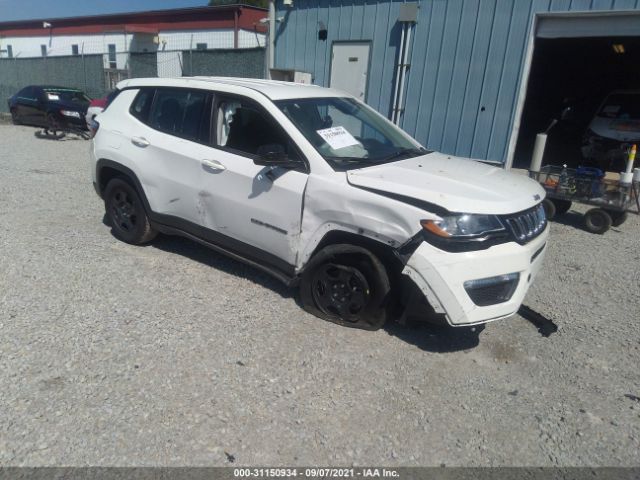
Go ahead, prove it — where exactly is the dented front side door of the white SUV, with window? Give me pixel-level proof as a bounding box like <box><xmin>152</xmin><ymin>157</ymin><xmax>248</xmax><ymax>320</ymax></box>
<box><xmin>198</xmin><ymin>97</ymin><xmax>308</xmax><ymax>265</ymax></box>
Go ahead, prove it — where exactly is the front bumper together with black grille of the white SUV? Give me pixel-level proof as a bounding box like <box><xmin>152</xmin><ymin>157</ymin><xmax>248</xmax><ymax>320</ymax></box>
<box><xmin>398</xmin><ymin>205</ymin><xmax>548</xmax><ymax>326</ymax></box>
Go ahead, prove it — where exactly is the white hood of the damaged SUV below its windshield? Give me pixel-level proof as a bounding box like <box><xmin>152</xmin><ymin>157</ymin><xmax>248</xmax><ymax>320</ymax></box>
<box><xmin>347</xmin><ymin>152</ymin><xmax>545</xmax><ymax>215</ymax></box>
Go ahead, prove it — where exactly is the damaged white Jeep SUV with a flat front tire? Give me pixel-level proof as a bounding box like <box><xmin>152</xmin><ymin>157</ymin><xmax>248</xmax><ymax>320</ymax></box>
<box><xmin>91</xmin><ymin>77</ymin><xmax>548</xmax><ymax>329</ymax></box>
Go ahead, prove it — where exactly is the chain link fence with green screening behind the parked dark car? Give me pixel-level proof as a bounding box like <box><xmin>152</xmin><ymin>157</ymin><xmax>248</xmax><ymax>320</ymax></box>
<box><xmin>0</xmin><ymin>30</ymin><xmax>265</xmax><ymax>112</ymax></box>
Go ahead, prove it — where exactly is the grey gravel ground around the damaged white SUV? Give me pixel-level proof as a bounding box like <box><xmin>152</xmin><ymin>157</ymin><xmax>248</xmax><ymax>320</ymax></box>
<box><xmin>0</xmin><ymin>125</ymin><xmax>640</xmax><ymax>466</ymax></box>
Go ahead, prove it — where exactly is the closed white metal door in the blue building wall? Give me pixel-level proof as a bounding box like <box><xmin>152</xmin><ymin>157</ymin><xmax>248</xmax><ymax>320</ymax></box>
<box><xmin>329</xmin><ymin>42</ymin><xmax>371</xmax><ymax>101</ymax></box>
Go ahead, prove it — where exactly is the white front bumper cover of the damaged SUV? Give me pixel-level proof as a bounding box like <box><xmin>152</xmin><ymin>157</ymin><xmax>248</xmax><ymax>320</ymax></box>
<box><xmin>402</xmin><ymin>226</ymin><xmax>549</xmax><ymax>326</ymax></box>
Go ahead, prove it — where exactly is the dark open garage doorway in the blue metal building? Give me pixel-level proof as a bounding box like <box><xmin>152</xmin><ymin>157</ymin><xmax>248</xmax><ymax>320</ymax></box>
<box><xmin>513</xmin><ymin>27</ymin><xmax>640</xmax><ymax>171</ymax></box>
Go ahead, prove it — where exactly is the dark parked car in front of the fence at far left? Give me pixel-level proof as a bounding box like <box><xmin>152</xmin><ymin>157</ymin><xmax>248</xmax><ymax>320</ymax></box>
<box><xmin>8</xmin><ymin>86</ymin><xmax>91</xmax><ymax>130</ymax></box>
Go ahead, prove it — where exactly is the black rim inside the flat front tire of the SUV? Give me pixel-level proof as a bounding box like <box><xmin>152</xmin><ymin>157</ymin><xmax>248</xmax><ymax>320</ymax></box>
<box><xmin>311</xmin><ymin>263</ymin><xmax>370</xmax><ymax>322</ymax></box>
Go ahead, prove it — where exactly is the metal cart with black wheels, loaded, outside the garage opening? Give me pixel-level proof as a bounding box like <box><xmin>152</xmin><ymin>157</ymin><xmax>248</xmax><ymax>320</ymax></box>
<box><xmin>529</xmin><ymin>165</ymin><xmax>640</xmax><ymax>233</ymax></box>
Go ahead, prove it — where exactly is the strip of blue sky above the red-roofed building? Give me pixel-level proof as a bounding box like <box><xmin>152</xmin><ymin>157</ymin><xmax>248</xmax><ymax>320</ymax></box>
<box><xmin>0</xmin><ymin>0</ymin><xmax>208</xmax><ymax>22</ymax></box>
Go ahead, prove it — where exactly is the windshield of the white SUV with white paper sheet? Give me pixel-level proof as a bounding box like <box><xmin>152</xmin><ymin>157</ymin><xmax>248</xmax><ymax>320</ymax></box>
<box><xmin>275</xmin><ymin>97</ymin><xmax>429</xmax><ymax>169</ymax></box>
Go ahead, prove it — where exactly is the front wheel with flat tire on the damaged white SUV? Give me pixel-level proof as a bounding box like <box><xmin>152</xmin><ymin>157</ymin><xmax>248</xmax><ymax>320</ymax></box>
<box><xmin>300</xmin><ymin>244</ymin><xmax>391</xmax><ymax>330</ymax></box>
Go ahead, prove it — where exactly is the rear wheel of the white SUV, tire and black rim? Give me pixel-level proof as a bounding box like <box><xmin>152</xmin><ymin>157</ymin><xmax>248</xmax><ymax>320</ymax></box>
<box><xmin>104</xmin><ymin>177</ymin><xmax>157</xmax><ymax>245</ymax></box>
